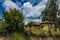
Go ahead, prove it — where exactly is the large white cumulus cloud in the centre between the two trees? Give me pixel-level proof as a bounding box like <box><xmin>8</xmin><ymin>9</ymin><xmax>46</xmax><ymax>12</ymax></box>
<box><xmin>23</xmin><ymin>0</ymin><xmax>47</xmax><ymax>21</ymax></box>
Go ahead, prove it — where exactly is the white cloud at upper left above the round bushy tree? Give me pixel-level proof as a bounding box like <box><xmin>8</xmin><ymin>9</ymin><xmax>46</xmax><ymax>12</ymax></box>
<box><xmin>3</xmin><ymin>0</ymin><xmax>19</xmax><ymax>10</ymax></box>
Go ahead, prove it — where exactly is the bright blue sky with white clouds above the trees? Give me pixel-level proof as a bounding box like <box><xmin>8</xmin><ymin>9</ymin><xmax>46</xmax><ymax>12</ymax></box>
<box><xmin>0</xmin><ymin>0</ymin><xmax>59</xmax><ymax>22</ymax></box>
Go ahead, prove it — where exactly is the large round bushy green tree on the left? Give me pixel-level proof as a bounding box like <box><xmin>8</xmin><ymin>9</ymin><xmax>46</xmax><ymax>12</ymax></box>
<box><xmin>3</xmin><ymin>9</ymin><xmax>24</xmax><ymax>33</ymax></box>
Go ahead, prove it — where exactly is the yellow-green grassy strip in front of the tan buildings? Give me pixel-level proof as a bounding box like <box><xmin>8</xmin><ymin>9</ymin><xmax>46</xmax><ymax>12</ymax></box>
<box><xmin>31</xmin><ymin>28</ymin><xmax>60</xmax><ymax>37</ymax></box>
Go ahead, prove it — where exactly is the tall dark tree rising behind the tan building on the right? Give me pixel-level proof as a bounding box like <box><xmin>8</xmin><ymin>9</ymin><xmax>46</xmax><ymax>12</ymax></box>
<box><xmin>41</xmin><ymin>0</ymin><xmax>58</xmax><ymax>26</ymax></box>
